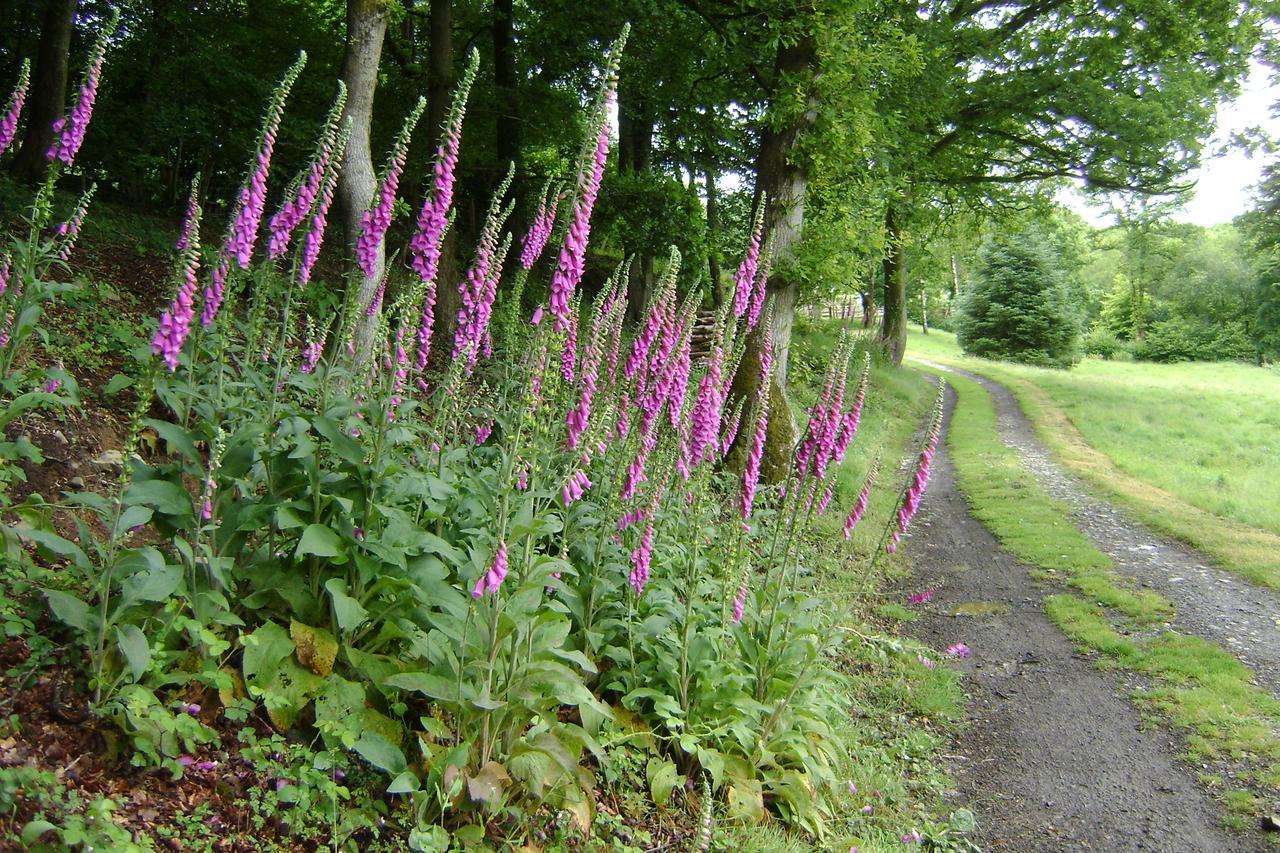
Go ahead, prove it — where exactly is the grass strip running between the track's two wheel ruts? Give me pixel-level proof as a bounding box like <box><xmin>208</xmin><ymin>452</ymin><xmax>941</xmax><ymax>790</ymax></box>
<box><xmin>931</xmin><ymin>361</ymin><xmax>1280</xmax><ymax>827</ymax></box>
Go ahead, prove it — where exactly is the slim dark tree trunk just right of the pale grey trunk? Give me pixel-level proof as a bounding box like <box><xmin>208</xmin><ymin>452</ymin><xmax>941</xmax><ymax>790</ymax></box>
<box><xmin>426</xmin><ymin>0</ymin><xmax>463</xmax><ymax>355</ymax></box>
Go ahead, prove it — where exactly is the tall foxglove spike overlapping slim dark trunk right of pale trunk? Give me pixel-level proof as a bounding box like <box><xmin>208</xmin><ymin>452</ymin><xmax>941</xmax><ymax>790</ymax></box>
<box><xmin>408</xmin><ymin>50</ymin><xmax>480</xmax><ymax>371</ymax></box>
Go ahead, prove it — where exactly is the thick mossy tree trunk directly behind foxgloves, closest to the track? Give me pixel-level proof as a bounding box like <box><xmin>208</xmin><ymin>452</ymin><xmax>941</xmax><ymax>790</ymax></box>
<box><xmin>733</xmin><ymin>35</ymin><xmax>818</xmax><ymax>482</ymax></box>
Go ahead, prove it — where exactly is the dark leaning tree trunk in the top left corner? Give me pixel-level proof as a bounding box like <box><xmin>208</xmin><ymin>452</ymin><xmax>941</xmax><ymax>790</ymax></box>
<box><xmin>12</xmin><ymin>0</ymin><xmax>76</xmax><ymax>183</ymax></box>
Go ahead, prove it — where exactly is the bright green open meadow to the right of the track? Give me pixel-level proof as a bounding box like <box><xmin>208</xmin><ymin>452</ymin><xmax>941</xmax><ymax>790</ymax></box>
<box><xmin>910</xmin><ymin>325</ymin><xmax>1280</xmax><ymax>589</ymax></box>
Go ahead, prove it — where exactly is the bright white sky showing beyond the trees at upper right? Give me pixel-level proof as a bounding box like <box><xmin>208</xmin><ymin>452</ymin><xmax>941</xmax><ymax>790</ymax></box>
<box><xmin>1059</xmin><ymin>63</ymin><xmax>1280</xmax><ymax>228</ymax></box>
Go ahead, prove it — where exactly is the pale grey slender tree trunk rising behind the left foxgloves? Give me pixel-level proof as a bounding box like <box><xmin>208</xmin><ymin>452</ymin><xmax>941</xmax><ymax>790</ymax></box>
<box><xmin>338</xmin><ymin>0</ymin><xmax>387</xmax><ymax>361</ymax></box>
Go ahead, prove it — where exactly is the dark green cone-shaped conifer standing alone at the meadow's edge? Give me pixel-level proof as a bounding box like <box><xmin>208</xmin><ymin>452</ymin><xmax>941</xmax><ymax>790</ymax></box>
<box><xmin>955</xmin><ymin>229</ymin><xmax>1080</xmax><ymax>368</ymax></box>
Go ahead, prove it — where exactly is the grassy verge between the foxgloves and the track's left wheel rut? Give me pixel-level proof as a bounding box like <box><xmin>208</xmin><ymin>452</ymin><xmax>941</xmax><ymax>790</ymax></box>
<box><xmin>716</xmin><ymin>315</ymin><xmax>973</xmax><ymax>852</ymax></box>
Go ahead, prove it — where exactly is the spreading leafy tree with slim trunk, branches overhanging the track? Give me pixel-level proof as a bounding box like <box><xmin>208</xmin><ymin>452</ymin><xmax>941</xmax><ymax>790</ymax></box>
<box><xmin>881</xmin><ymin>0</ymin><xmax>1261</xmax><ymax>360</ymax></box>
